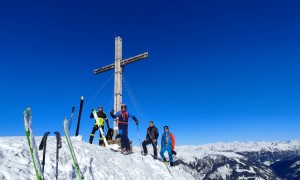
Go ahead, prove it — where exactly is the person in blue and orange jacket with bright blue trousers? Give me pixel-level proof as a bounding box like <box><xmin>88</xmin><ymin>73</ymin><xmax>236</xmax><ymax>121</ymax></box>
<box><xmin>160</xmin><ymin>126</ymin><xmax>175</xmax><ymax>166</ymax></box>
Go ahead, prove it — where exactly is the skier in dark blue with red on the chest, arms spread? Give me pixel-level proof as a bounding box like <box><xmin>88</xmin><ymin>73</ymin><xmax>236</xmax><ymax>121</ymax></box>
<box><xmin>110</xmin><ymin>104</ymin><xmax>139</xmax><ymax>154</ymax></box>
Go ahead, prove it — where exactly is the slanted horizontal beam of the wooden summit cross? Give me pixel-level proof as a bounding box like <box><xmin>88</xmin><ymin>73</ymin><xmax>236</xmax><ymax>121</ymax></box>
<box><xmin>94</xmin><ymin>52</ymin><xmax>148</xmax><ymax>75</ymax></box>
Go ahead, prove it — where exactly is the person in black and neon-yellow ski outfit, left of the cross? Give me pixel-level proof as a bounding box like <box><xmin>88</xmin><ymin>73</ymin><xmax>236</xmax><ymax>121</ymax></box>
<box><xmin>89</xmin><ymin>106</ymin><xmax>109</xmax><ymax>146</ymax></box>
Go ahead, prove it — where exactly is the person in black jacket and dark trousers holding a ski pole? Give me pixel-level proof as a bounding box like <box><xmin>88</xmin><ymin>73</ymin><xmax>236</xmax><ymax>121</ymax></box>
<box><xmin>142</xmin><ymin>121</ymin><xmax>159</xmax><ymax>159</ymax></box>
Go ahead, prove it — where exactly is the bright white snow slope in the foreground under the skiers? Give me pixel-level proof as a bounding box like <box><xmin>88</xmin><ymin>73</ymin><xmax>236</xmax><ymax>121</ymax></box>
<box><xmin>0</xmin><ymin>135</ymin><xmax>194</xmax><ymax>180</ymax></box>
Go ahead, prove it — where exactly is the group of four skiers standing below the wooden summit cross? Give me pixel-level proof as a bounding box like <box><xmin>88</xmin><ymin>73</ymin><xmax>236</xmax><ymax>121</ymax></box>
<box><xmin>89</xmin><ymin>104</ymin><xmax>176</xmax><ymax>166</ymax></box>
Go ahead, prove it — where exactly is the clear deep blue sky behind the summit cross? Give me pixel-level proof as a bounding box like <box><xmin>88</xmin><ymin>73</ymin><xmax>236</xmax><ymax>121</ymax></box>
<box><xmin>0</xmin><ymin>0</ymin><xmax>300</xmax><ymax>145</ymax></box>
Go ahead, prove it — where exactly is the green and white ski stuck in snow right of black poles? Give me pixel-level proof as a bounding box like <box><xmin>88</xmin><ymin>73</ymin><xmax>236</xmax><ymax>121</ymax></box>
<box><xmin>64</xmin><ymin>118</ymin><xmax>84</xmax><ymax>180</ymax></box>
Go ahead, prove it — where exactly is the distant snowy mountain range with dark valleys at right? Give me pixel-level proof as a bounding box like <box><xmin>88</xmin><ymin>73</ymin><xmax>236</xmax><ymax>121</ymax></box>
<box><xmin>176</xmin><ymin>140</ymin><xmax>300</xmax><ymax>180</ymax></box>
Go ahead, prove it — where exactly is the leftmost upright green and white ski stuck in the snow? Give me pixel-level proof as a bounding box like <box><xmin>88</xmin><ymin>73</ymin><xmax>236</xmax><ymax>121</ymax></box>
<box><xmin>23</xmin><ymin>107</ymin><xmax>44</xmax><ymax>180</ymax></box>
